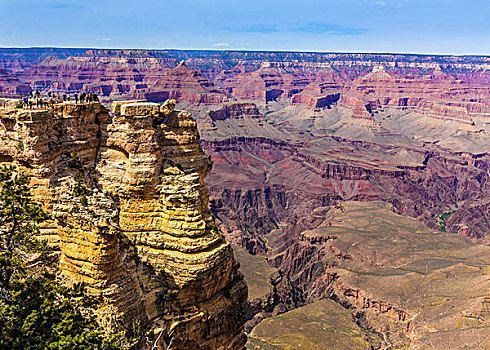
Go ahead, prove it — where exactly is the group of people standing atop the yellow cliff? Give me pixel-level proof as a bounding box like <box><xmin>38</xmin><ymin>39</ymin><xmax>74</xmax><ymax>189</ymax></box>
<box><xmin>19</xmin><ymin>90</ymin><xmax>99</xmax><ymax>109</ymax></box>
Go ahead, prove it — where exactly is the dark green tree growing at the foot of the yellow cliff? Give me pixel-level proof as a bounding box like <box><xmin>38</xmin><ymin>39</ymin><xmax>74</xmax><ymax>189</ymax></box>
<box><xmin>0</xmin><ymin>166</ymin><xmax>123</xmax><ymax>350</ymax></box>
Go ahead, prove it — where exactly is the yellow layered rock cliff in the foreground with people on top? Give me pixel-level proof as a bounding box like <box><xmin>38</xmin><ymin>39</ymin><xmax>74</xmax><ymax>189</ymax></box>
<box><xmin>0</xmin><ymin>101</ymin><xmax>247</xmax><ymax>349</ymax></box>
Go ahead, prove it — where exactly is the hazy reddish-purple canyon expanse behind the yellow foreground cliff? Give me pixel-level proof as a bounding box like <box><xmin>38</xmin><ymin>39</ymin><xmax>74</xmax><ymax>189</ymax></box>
<box><xmin>0</xmin><ymin>49</ymin><xmax>490</xmax><ymax>349</ymax></box>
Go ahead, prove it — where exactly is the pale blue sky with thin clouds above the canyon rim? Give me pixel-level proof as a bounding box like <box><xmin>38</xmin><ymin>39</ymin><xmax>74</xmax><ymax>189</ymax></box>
<box><xmin>0</xmin><ymin>0</ymin><xmax>490</xmax><ymax>55</ymax></box>
